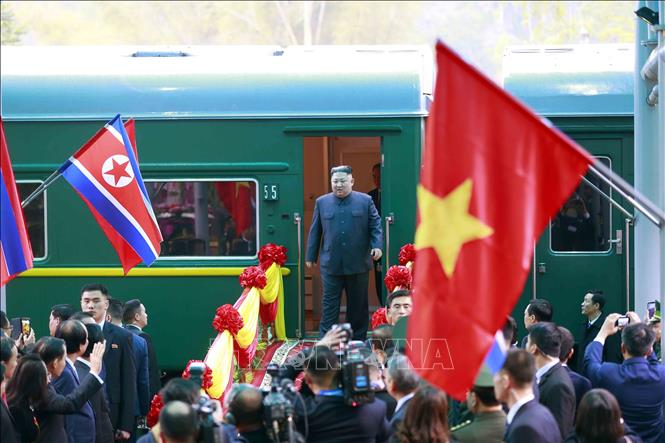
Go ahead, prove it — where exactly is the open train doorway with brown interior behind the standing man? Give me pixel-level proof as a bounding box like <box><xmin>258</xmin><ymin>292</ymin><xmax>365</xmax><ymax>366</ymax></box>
<box><xmin>302</xmin><ymin>136</ymin><xmax>383</xmax><ymax>337</ymax></box>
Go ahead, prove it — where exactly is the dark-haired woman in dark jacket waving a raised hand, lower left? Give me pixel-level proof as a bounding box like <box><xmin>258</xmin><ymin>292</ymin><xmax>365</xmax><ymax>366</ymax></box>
<box><xmin>7</xmin><ymin>337</ymin><xmax>104</xmax><ymax>443</ymax></box>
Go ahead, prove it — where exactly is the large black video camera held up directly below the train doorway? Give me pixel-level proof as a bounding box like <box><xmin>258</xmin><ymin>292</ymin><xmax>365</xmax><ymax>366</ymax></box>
<box><xmin>333</xmin><ymin>323</ymin><xmax>374</xmax><ymax>406</ymax></box>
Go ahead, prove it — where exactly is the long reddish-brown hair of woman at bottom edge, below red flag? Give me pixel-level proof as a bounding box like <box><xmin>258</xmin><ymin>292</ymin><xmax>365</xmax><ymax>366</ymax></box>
<box><xmin>397</xmin><ymin>385</ymin><xmax>450</xmax><ymax>443</ymax></box>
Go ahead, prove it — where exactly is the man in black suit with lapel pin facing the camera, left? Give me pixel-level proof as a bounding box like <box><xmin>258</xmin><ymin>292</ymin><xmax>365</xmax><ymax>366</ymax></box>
<box><xmin>81</xmin><ymin>284</ymin><xmax>136</xmax><ymax>440</ymax></box>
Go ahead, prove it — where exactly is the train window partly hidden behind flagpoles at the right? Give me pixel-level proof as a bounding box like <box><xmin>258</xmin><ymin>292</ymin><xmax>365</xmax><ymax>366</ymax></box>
<box><xmin>550</xmin><ymin>157</ymin><xmax>612</xmax><ymax>253</ymax></box>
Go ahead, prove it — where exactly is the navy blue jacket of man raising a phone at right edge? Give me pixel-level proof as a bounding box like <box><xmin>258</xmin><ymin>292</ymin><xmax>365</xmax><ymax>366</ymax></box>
<box><xmin>584</xmin><ymin>341</ymin><xmax>665</xmax><ymax>443</ymax></box>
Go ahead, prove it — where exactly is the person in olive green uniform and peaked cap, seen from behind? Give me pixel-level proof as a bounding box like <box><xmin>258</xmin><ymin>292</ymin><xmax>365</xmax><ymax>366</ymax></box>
<box><xmin>451</xmin><ymin>365</ymin><xmax>506</xmax><ymax>443</ymax></box>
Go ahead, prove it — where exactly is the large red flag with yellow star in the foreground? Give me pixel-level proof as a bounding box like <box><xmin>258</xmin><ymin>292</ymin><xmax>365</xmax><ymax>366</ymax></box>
<box><xmin>407</xmin><ymin>43</ymin><xmax>592</xmax><ymax>399</ymax></box>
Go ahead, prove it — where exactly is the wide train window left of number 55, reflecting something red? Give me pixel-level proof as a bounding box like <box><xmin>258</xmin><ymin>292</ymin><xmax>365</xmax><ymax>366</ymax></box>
<box><xmin>146</xmin><ymin>179</ymin><xmax>258</xmax><ymax>258</ymax></box>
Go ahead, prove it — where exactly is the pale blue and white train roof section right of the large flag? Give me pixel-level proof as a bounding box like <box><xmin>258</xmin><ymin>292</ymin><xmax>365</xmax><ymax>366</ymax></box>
<box><xmin>503</xmin><ymin>44</ymin><xmax>635</xmax><ymax>117</ymax></box>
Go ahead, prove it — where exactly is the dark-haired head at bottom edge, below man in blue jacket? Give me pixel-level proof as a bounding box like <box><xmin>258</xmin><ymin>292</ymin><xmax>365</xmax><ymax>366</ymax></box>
<box><xmin>575</xmin><ymin>389</ymin><xmax>624</xmax><ymax>443</ymax></box>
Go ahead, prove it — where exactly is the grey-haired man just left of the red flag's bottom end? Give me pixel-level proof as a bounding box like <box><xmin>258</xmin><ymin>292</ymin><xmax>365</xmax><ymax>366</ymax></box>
<box><xmin>386</xmin><ymin>354</ymin><xmax>420</xmax><ymax>437</ymax></box>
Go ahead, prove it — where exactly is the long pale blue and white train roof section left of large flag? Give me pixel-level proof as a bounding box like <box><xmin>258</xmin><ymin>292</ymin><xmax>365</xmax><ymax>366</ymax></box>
<box><xmin>0</xmin><ymin>46</ymin><xmax>433</xmax><ymax>120</ymax></box>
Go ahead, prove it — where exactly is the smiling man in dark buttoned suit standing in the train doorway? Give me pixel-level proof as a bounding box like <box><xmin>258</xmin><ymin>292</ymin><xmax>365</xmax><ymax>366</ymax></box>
<box><xmin>305</xmin><ymin>166</ymin><xmax>382</xmax><ymax>341</ymax></box>
